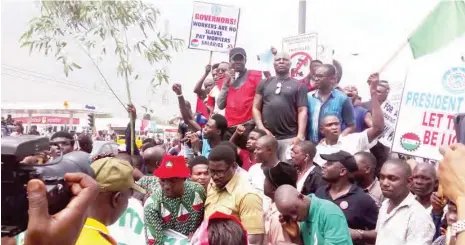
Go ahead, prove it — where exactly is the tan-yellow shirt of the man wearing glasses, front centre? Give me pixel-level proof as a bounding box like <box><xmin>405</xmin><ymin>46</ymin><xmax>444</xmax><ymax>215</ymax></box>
<box><xmin>205</xmin><ymin>173</ymin><xmax>265</xmax><ymax>235</ymax></box>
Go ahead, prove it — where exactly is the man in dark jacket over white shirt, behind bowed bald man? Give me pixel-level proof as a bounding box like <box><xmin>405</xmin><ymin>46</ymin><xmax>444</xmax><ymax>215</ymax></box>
<box><xmin>291</xmin><ymin>141</ymin><xmax>326</xmax><ymax>195</ymax></box>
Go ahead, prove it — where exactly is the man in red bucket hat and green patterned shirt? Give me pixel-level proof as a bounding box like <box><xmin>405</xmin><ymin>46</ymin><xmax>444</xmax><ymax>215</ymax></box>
<box><xmin>144</xmin><ymin>156</ymin><xmax>206</xmax><ymax>245</ymax></box>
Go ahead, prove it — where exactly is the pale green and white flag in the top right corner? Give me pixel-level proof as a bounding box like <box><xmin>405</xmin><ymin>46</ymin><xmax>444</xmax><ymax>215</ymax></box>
<box><xmin>408</xmin><ymin>0</ymin><xmax>465</xmax><ymax>59</ymax></box>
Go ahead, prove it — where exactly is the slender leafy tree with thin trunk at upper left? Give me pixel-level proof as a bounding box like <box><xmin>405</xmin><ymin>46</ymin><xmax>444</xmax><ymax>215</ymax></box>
<box><xmin>20</xmin><ymin>0</ymin><xmax>184</xmax><ymax>154</ymax></box>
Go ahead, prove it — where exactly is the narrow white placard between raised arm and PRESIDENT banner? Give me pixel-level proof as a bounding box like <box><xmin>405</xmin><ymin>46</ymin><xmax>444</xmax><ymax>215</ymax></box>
<box><xmin>379</xmin><ymin>101</ymin><xmax>399</xmax><ymax>148</ymax></box>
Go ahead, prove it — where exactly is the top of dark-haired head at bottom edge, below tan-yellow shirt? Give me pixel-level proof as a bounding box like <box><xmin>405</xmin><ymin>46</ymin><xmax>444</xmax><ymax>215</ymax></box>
<box><xmin>207</xmin><ymin>219</ymin><xmax>247</xmax><ymax>245</ymax></box>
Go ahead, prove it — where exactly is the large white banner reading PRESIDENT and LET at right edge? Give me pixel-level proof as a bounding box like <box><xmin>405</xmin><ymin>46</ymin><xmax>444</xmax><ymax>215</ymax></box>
<box><xmin>392</xmin><ymin>57</ymin><xmax>465</xmax><ymax>160</ymax></box>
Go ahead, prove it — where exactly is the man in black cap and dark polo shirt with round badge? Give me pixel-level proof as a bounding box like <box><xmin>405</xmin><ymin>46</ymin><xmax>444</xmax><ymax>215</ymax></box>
<box><xmin>315</xmin><ymin>151</ymin><xmax>378</xmax><ymax>244</ymax></box>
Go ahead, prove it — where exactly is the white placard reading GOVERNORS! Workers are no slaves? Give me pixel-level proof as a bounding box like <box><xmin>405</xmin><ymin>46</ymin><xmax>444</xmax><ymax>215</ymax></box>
<box><xmin>189</xmin><ymin>2</ymin><xmax>240</xmax><ymax>53</ymax></box>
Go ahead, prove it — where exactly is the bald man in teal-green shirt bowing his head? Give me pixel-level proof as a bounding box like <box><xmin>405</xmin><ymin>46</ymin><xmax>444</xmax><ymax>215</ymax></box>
<box><xmin>274</xmin><ymin>185</ymin><xmax>352</xmax><ymax>245</ymax></box>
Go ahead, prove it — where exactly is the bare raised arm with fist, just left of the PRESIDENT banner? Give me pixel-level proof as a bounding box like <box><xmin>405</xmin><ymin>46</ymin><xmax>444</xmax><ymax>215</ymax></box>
<box><xmin>367</xmin><ymin>73</ymin><xmax>384</xmax><ymax>142</ymax></box>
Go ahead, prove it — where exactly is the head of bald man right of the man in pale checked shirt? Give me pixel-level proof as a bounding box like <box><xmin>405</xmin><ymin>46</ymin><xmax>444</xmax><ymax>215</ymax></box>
<box><xmin>410</xmin><ymin>163</ymin><xmax>439</xmax><ymax>213</ymax></box>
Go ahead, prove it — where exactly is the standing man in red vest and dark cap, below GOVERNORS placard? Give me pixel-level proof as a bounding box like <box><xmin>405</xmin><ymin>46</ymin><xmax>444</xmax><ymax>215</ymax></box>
<box><xmin>217</xmin><ymin>48</ymin><xmax>262</xmax><ymax>149</ymax></box>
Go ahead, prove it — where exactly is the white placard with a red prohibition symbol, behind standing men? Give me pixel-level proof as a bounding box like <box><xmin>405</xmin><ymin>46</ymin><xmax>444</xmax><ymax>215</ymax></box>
<box><xmin>283</xmin><ymin>33</ymin><xmax>318</xmax><ymax>80</ymax></box>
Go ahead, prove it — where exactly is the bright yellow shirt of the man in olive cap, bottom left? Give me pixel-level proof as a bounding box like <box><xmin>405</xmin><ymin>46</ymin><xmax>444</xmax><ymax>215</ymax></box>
<box><xmin>76</xmin><ymin>218</ymin><xmax>117</xmax><ymax>245</ymax></box>
